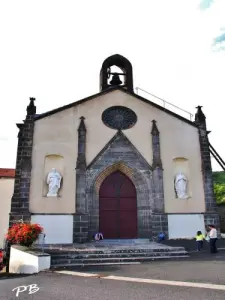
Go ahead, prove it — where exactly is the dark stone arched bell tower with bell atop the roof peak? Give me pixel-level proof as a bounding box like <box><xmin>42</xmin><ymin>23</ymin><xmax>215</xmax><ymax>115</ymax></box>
<box><xmin>100</xmin><ymin>54</ymin><xmax>133</xmax><ymax>92</ymax></box>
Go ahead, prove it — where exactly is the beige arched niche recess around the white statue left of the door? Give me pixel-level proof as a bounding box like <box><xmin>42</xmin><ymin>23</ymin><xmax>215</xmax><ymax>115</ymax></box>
<box><xmin>42</xmin><ymin>154</ymin><xmax>64</xmax><ymax>197</ymax></box>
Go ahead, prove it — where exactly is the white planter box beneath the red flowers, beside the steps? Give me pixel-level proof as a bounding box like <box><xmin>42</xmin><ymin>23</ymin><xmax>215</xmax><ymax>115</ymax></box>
<box><xmin>9</xmin><ymin>246</ymin><xmax>51</xmax><ymax>274</ymax></box>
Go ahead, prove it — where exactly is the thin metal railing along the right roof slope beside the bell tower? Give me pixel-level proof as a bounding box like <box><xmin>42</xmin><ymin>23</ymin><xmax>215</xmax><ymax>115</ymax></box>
<box><xmin>135</xmin><ymin>87</ymin><xmax>193</xmax><ymax>121</ymax></box>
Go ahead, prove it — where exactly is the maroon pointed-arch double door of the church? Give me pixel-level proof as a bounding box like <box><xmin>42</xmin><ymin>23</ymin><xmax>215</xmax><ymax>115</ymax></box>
<box><xmin>99</xmin><ymin>171</ymin><xmax>137</xmax><ymax>239</ymax></box>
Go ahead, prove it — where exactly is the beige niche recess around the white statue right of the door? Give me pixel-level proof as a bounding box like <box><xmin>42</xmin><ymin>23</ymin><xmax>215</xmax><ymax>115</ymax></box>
<box><xmin>173</xmin><ymin>157</ymin><xmax>192</xmax><ymax>200</ymax></box>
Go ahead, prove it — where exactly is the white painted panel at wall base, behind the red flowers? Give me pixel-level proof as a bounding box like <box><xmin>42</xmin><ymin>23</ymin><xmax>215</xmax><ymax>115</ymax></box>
<box><xmin>31</xmin><ymin>215</ymin><xmax>73</xmax><ymax>244</ymax></box>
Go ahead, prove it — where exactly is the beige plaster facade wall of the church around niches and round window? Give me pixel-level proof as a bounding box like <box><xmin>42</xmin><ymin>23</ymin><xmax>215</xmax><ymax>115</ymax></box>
<box><xmin>29</xmin><ymin>90</ymin><xmax>205</xmax><ymax>214</ymax></box>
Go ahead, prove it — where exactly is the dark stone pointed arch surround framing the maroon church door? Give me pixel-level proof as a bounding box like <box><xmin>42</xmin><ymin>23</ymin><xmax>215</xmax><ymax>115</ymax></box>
<box><xmin>86</xmin><ymin>161</ymin><xmax>154</xmax><ymax>238</ymax></box>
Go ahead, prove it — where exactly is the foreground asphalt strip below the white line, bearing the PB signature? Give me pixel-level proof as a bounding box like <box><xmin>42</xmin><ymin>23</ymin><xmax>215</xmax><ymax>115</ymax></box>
<box><xmin>0</xmin><ymin>273</ymin><xmax>225</xmax><ymax>300</ymax></box>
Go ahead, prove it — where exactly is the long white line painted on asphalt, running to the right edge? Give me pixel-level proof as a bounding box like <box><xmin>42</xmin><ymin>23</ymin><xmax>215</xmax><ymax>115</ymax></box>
<box><xmin>103</xmin><ymin>276</ymin><xmax>225</xmax><ymax>291</ymax></box>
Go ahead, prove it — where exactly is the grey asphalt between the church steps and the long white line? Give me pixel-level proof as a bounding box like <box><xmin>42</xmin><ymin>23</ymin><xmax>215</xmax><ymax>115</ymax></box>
<box><xmin>64</xmin><ymin>251</ymin><xmax>225</xmax><ymax>284</ymax></box>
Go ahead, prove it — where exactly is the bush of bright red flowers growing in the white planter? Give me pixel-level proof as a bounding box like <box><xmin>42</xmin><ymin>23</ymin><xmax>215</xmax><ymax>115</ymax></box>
<box><xmin>6</xmin><ymin>222</ymin><xmax>43</xmax><ymax>247</ymax></box>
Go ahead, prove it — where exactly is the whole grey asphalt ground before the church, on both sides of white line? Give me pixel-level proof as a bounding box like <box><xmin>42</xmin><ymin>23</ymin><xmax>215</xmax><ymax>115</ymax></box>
<box><xmin>0</xmin><ymin>250</ymin><xmax>225</xmax><ymax>300</ymax></box>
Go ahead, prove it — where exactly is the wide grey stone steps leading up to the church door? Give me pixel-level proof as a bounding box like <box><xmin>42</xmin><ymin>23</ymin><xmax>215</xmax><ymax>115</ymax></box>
<box><xmin>41</xmin><ymin>246</ymin><xmax>189</xmax><ymax>268</ymax></box>
